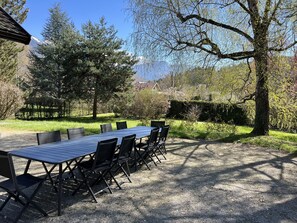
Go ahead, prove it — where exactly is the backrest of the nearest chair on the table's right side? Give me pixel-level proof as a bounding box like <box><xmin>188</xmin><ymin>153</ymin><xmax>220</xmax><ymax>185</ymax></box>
<box><xmin>93</xmin><ymin>138</ymin><xmax>118</xmax><ymax>168</ymax></box>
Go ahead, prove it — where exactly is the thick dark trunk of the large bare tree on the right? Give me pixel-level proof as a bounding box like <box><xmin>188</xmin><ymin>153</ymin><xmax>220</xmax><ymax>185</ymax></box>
<box><xmin>252</xmin><ymin>29</ymin><xmax>269</xmax><ymax>135</ymax></box>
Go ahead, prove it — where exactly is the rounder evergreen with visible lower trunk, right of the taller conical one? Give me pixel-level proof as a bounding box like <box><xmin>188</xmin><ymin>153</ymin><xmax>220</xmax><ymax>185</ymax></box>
<box><xmin>82</xmin><ymin>18</ymin><xmax>136</xmax><ymax>119</ymax></box>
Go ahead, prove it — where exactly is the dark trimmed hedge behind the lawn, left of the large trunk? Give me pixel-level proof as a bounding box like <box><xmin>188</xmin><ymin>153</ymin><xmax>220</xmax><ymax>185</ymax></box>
<box><xmin>167</xmin><ymin>100</ymin><xmax>249</xmax><ymax>125</ymax></box>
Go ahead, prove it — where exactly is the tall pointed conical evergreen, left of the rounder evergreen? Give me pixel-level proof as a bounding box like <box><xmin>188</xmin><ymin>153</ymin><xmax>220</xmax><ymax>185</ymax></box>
<box><xmin>29</xmin><ymin>5</ymin><xmax>79</xmax><ymax>99</ymax></box>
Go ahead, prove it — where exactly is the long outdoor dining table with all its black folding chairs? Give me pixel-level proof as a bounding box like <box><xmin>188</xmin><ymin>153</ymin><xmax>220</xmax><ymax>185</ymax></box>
<box><xmin>0</xmin><ymin>121</ymin><xmax>169</xmax><ymax>222</ymax></box>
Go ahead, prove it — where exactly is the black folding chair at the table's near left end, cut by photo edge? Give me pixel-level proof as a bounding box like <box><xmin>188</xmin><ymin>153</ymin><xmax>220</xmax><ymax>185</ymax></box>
<box><xmin>0</xmin><ymin>151</ymin><xmax>47</xmax><ymax>222</ymax></box>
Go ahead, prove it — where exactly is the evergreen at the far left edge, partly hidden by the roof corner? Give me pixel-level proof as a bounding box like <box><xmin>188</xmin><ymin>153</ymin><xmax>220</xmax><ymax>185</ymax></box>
<box><xmin>0</xmin><ymin>0</ymin><xmax>28</xmax><ymax>82</ymax></box>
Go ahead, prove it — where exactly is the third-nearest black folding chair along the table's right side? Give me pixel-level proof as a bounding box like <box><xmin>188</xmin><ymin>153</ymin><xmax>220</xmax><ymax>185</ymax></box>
<box><xmin>135</xmin><ymin>128</ymin><xmax>161</xmax><ymax>169</ymax></box>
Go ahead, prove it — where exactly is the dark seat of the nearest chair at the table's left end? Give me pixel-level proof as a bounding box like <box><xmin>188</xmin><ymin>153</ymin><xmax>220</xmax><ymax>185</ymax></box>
<box><xmin>0</xmin><ymin>173</ymin><xmax>44</xmax><ymax>191</ymax></box>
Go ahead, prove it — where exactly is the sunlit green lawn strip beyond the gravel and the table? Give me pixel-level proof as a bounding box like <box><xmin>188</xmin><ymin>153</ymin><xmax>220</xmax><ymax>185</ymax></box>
<box><xmin>0</xmin><ymin>113</ymin><xmax>297</xmax><ymax>152</ymax></box>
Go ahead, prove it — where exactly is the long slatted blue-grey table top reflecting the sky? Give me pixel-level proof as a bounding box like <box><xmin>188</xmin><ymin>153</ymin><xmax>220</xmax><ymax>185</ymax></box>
<box><xmin>10</xmin><ymin>126</ymin><xmax>153</xmax><ymax>164</ymax></box>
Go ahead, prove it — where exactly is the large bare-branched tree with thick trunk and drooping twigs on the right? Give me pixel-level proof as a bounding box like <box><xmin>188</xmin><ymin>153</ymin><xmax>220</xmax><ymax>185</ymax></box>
<box><xmin>130</xmin><ymin>0</ymin><xmax>297</xmax><ymax>135</ymax></box>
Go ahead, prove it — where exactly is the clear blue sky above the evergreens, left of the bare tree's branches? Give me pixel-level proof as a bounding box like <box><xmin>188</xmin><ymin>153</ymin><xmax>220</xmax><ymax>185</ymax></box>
<box><xmin>22</xmin><ymin>0</ymin><xmax>133</xmax><ymax>40</ymax></box>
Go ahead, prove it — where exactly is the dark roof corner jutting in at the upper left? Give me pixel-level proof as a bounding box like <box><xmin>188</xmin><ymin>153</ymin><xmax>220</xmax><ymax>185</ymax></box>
<box><xmin>0</xmin><ymin>7</ymin><xmax>31</xmax><ymax>44</ymax></box>
